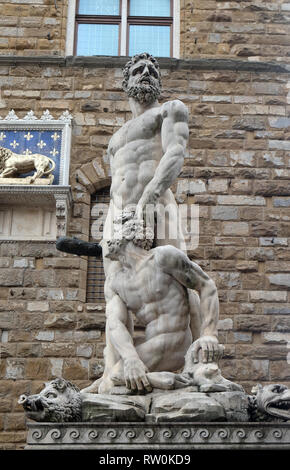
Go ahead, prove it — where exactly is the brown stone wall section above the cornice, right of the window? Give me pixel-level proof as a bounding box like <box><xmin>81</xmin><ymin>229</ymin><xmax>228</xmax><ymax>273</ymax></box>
<box><xmin>180</xmin><ymin>0</ymin><xmax>290</xmax><ymax>62</ymax></box>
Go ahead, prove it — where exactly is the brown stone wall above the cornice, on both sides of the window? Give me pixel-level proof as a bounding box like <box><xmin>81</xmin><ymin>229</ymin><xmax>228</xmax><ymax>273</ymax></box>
<box><xmin>0</xmin><ymin>0</ymin><xmax>290</xmax><ymax>62</ymax></box>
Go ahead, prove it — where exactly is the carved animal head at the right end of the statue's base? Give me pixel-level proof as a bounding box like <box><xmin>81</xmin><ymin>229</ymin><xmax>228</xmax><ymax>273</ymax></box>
<box><xmin>255</xmin><ymin>384</ymin><xmax>290</xmax><ymax>420</ymax></box>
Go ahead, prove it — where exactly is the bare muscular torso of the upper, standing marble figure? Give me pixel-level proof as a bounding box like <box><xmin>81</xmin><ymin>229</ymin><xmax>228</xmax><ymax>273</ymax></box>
<box><xmin>108</xmin><ymin>107</ymin><xmax>163</xmax><ymax>209</ymax></box>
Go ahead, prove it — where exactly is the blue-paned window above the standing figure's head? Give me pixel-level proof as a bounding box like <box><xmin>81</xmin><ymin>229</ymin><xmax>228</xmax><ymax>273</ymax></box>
<box><xmin>74</xmin><ymin>0</ymin><xmax>179</xmax><ymax>57</ymax></box>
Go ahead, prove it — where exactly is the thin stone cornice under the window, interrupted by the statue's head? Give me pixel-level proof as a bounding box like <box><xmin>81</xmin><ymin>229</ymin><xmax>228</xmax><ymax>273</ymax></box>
<box><xmin>0</xmin><ymin>55</ymin><xmax>290</xmax><ymax>73</ymax></box>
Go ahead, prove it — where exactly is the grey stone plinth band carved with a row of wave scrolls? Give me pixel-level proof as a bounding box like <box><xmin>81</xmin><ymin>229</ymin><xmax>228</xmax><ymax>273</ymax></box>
<box><xmin>25</xmin><ymin>422</ymin><xmax>290</xmax><ymax>450</ymax></box>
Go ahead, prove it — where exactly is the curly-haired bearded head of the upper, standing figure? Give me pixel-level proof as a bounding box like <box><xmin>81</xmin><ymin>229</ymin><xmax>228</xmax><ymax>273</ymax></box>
<box><xmin>123</xmin><ymin>52</ymin><xmax>161</xmax><ymax>104</ymax></box>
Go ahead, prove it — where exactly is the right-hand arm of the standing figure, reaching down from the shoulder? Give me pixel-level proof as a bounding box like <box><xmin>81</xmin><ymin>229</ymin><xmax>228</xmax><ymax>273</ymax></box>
<box><xmin>137</xmin><ymin>100</ymin><xmax>189</xmax><ymax>218</ymax></box>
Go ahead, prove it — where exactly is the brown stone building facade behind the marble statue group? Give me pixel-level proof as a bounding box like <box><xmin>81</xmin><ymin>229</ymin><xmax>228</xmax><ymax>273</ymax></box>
<box><xmin>0</xmin><ymin>0</ymin><xmax>290</xmax><ymax>449</ymax></box>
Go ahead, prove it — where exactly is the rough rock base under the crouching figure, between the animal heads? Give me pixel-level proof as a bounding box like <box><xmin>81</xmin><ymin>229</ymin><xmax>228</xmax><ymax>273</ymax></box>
<box><xmin>82</xmin><ymin>387</ymin><xmax>249</xmax><ymax>423</ymax></box>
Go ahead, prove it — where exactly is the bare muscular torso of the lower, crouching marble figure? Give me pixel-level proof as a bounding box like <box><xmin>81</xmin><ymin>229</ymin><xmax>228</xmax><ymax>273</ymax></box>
<box><xmin>112</xmin><ymin>250</ymin><xmax>190</xmax><ymax>340</ymax></box>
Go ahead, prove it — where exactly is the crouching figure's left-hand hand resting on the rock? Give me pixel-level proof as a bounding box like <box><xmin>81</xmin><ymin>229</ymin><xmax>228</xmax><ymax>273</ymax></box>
<box><xmin>124</xmin><ymin>358</ymin><xmax>152</xmax><ymax>392</ymax></box>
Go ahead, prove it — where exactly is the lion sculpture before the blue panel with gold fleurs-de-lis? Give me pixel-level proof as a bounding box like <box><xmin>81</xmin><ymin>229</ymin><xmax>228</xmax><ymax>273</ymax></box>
<box><xmin>0</xmin><ymin>147</ymin><xmax>55</xmax><ymax>184</ymax></box>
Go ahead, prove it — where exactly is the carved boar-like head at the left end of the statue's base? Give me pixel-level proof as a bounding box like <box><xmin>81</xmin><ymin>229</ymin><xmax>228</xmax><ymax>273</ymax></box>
<box><xmin>18</xmin><ymin>379</ymin><xmax>82</xmax><ymax>423</ymax></box>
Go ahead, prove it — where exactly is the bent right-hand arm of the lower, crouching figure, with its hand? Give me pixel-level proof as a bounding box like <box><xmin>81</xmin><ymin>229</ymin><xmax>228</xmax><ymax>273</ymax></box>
<box><xmin>156</xmin><ymin>245</ymin><xmax>222</xmax><ymax>362</ymax></box>
